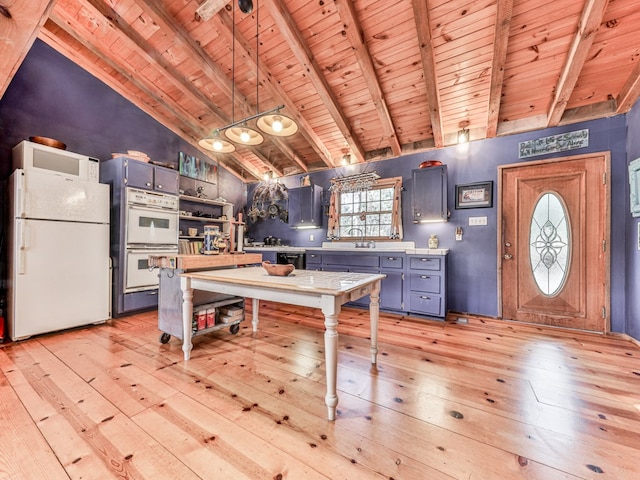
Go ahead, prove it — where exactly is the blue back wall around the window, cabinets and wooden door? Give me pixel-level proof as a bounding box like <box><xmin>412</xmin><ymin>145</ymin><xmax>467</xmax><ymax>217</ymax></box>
<box><xmin>247</xmin><ymin>115</ymin><xmax>628</xmax><ymax>332</ymax></box>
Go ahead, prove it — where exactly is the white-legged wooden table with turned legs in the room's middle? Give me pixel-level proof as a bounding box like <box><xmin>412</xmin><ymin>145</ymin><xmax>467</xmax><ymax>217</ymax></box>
<box><xmin>180</xmin><ymin>267</ymin><xmax>385</xmax><ymax>420</ymax></box>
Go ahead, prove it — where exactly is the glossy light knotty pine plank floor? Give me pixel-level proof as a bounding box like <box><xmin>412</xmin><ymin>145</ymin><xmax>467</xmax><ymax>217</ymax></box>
<box><xmin>0</xmin><ymin>302</ymin><xmax>640</xmax><ymax>480</ymax></box>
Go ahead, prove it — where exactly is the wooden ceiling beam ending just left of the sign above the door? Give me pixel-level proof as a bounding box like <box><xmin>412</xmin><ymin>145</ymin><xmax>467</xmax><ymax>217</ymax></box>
<box><xmin>485</xmin><ymin>0</ymin><xmax>513</xmax><ymax>138</ymax></box>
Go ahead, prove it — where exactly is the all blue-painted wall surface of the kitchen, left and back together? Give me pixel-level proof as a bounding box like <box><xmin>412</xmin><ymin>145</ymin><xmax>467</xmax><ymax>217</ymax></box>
<box><xmin>0</xmin><ymin>41</ymin><xmax>640</xmax><ymax>338</ymax></box>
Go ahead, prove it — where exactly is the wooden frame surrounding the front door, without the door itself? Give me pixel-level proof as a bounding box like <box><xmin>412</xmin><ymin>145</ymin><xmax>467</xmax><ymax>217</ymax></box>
<box><xmin>496</xmin><ymin>151</ymin><xmax>611</xmax><ymax>333</ymax></box>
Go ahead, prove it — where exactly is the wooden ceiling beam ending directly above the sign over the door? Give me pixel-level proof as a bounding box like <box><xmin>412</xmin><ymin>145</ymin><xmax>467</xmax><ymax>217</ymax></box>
<box><xmin>546</xmin><ymin>0</ymin><xmax>609</xmax><ymax>127</ymax></box>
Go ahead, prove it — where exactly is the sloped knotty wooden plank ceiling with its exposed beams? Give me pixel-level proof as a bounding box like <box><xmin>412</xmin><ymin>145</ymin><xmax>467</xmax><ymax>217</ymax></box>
<box><xmin>0</xmin><ymin>0</ymin><xmax>640</xmax><ymax>182</ymax></box>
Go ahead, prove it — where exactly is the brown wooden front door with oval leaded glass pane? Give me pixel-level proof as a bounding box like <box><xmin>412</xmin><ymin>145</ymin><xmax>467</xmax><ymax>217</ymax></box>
<box><xmin>498</xmin><ymin>153</ymin><xmax>610</xmax><ymax>332</ymax></box>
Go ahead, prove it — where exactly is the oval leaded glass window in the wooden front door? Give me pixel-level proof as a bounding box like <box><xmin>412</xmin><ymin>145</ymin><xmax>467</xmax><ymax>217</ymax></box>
<box><xmin>529</xmin><ymin>192</ymin><xmax>571</xmax><ymax>297</ymax></box>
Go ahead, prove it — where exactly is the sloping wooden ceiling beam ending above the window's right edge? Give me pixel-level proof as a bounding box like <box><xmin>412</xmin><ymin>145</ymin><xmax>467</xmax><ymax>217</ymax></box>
<box><xmin>334</xmin><ymin>0</ymin><xmax>402</xmax><ymax>157</ymax></box>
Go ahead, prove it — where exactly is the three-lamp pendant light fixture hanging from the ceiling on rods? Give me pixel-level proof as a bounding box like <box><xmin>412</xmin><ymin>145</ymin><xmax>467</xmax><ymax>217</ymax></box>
<box><xmin>198</xmin><ymin>0</ymin><xmax>298</xmax><ymax>153</ymax></box>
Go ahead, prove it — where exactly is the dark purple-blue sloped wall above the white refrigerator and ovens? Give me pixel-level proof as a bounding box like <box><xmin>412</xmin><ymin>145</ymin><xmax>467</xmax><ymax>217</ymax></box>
<box><xmin>0</xmin><ymin>40</ymin><xmax>245</xmax><ymax>207</ymax></box>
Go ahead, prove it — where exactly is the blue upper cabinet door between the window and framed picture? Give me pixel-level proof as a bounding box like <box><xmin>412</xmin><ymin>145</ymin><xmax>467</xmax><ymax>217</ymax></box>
<box><xmin>411</xmin><ymin>165</ymin><xmax>449</xmax><ymax>223</ymax></box>
